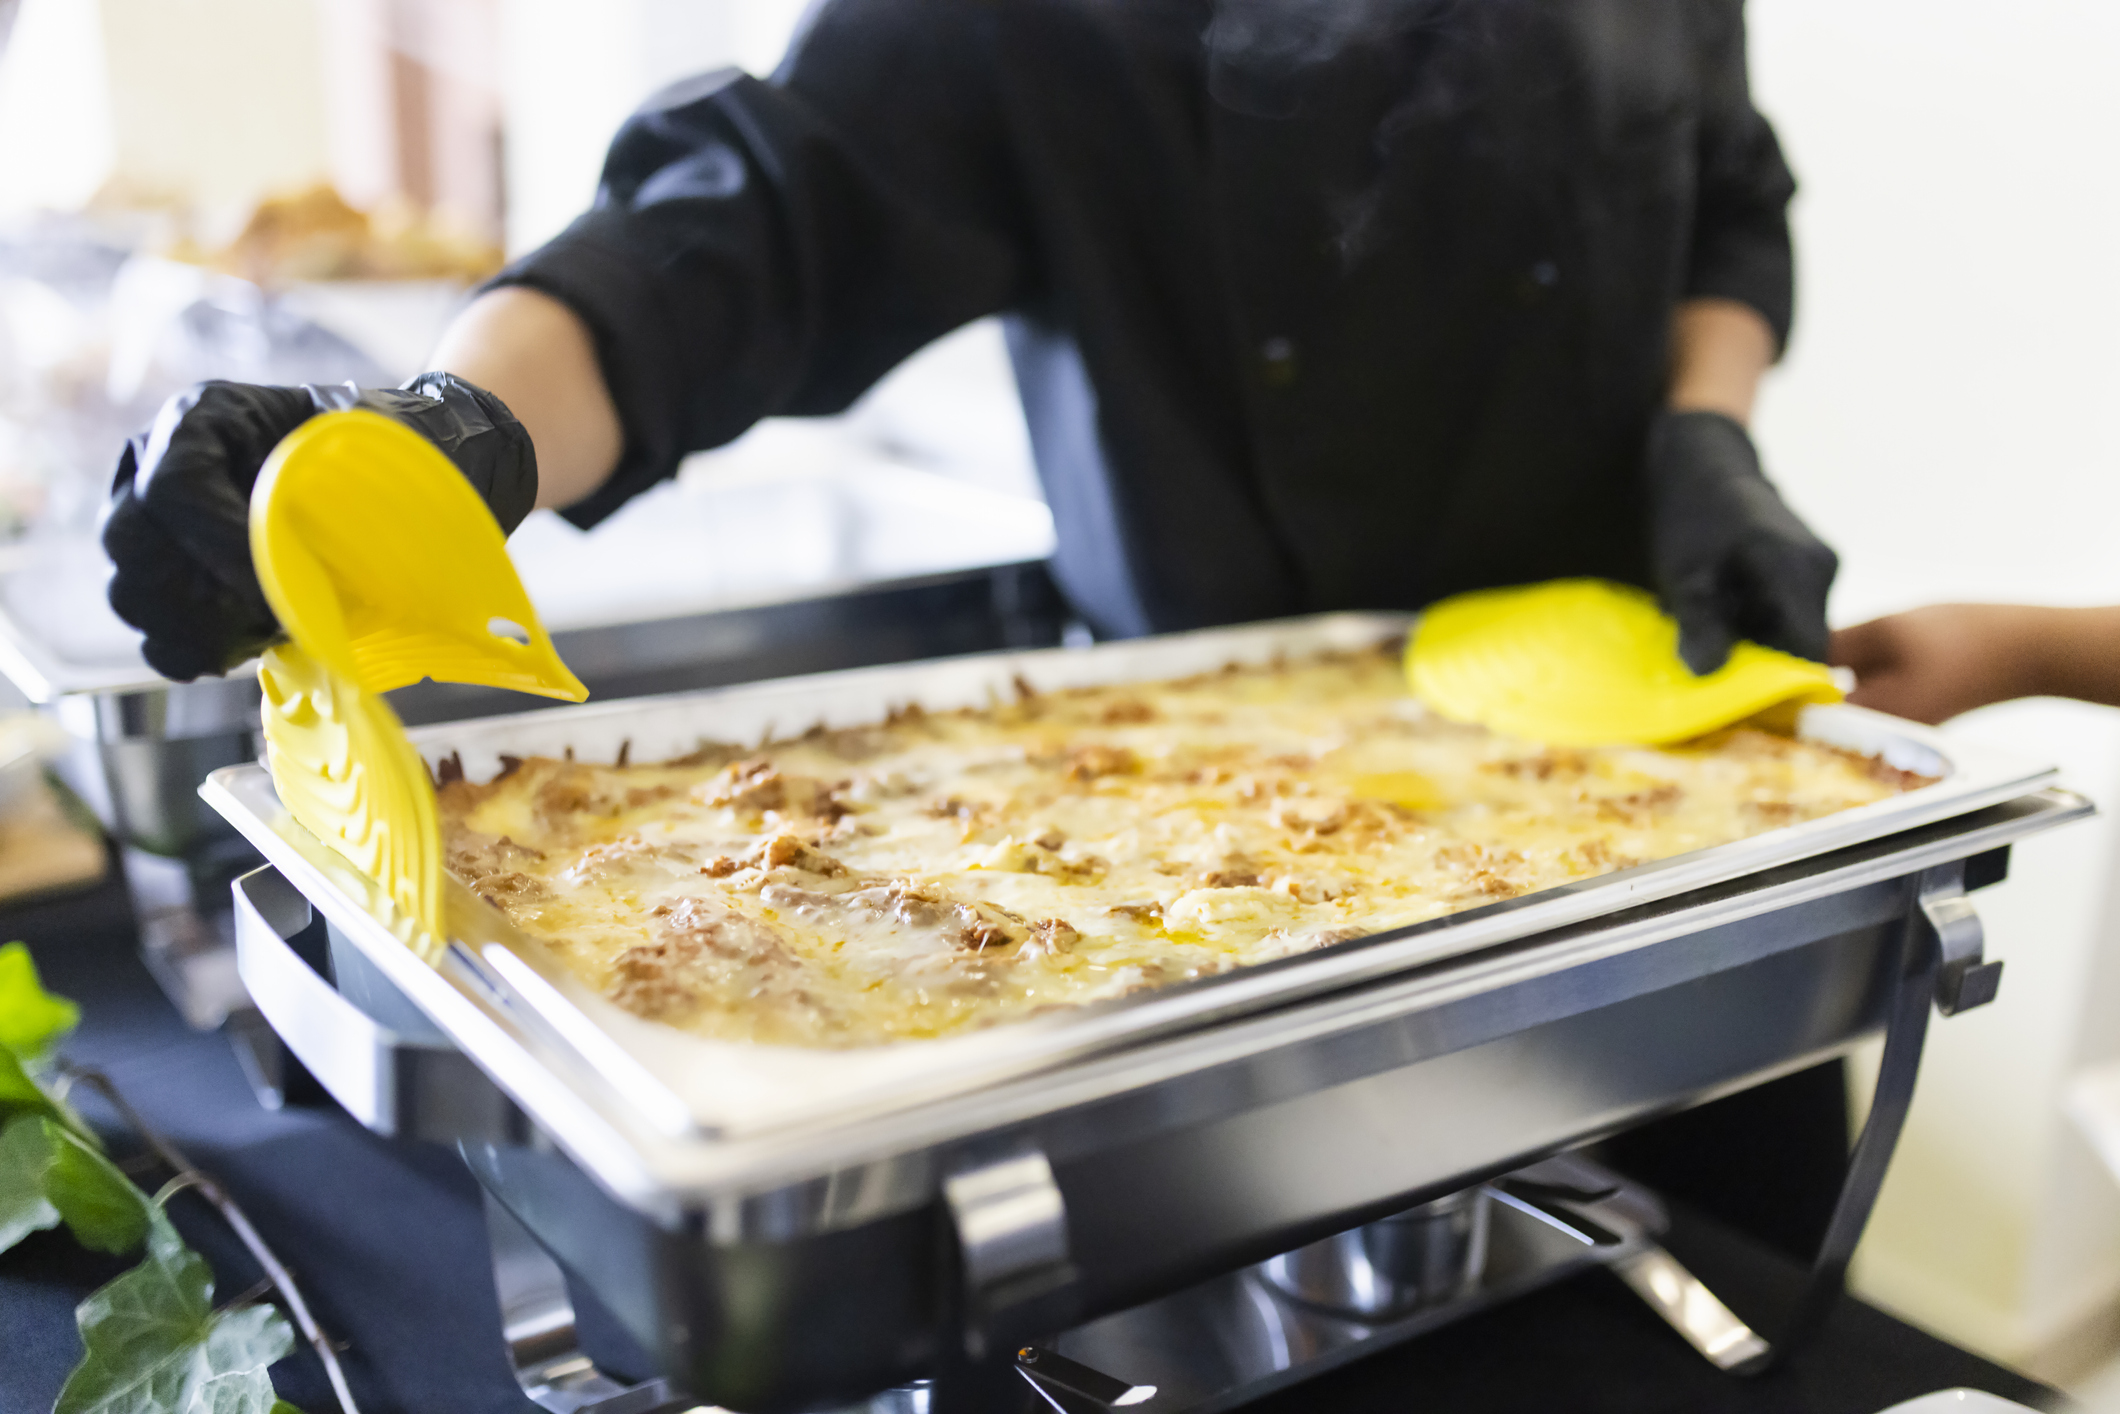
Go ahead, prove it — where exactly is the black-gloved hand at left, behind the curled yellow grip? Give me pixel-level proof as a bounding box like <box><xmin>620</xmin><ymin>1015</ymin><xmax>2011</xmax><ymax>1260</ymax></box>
<box><xmin>104</xmin><ymin>373</ymin><xmax>536</xmax><ymax>683</ymax></box>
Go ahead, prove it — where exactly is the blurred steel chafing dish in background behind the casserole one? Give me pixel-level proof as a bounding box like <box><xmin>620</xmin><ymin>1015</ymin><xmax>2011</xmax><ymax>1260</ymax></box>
<box><xmin>0</xmin><ymin>525</ymin><xmax>1064</xmax><ymax>1104</ymax></box>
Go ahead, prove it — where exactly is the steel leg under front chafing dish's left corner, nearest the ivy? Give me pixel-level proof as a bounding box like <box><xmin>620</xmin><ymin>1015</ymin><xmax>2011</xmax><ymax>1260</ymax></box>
<box><xmin>485</xmin><ymin>1194</ymin><xmax>697</xmax><ymax>1414</ymax></box>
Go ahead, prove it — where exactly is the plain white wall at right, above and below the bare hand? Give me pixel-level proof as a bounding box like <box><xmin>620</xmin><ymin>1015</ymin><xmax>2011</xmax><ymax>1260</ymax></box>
<box><xmin>1749</xmin><ymin>0</ymin><xmax>2120</xmax><ymax>1367</ymax></box>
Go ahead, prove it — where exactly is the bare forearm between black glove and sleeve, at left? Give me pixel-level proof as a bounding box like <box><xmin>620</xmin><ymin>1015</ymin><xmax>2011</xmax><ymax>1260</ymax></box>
<box><xmin>428</xmin><ymin>286</ymin><xmax>625</xmax><ymax>507</ymax></box>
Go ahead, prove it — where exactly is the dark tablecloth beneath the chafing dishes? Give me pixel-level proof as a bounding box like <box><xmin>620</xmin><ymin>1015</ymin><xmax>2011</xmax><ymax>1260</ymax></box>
<box><xmin>0</xmin><ymin>886</ymin><xmax>2069</xmax><ymax>1414</ymax></box>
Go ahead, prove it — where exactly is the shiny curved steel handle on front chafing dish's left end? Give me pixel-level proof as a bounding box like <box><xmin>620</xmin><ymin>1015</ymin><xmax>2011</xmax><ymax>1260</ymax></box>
<box><xmin>231</xmin><ymin>865</ymin><xmax>490</xmax><ymax>1138</ymax></box>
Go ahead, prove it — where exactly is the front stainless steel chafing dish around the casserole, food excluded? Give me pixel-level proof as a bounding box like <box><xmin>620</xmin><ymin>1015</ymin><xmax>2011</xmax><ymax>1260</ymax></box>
<box><xmin>204</xmin><ymin>615</ymin><xmax>2088</xmax><ymax>1412</ymax></box>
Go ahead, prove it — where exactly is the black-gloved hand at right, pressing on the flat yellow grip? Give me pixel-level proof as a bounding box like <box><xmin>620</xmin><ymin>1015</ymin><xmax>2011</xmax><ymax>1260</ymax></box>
<box><xmin>1643</xmin><ymin>411</ymin><xmax>1840</xmax><ymax>674</ymax></box>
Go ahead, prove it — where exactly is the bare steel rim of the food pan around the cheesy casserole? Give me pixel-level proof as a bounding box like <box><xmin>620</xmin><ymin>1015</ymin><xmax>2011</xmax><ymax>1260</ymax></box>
<box><xmin>206</xmin><ymin>615</ymin><xmax>2052</xmax><ymax>1153</ymax></box>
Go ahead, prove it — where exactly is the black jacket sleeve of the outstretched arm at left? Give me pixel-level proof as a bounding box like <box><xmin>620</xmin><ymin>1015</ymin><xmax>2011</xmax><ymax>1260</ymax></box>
<box><xmin>494</xmin><ymin>0</ymin><xmax>1028</xmax><ymax>526</ymax></box>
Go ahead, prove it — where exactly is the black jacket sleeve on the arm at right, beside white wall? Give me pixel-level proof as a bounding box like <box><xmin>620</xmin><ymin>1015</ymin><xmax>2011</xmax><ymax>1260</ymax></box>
<box><xmin>1685</xmin><ymin>0</ymin><xmax>1796</xmax><ymax>348</ymax></box>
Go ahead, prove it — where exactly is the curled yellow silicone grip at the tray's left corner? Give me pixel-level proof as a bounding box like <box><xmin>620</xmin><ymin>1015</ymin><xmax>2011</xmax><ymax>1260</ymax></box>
<box><xmin>250</xmin><ymin>411</ymin><xmax>589</xmax><ymax>952</ymax></box>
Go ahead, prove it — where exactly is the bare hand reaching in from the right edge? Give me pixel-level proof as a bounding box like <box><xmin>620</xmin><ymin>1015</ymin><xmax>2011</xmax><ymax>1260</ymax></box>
<box><xmin>1830</xmin><ymin>604</ymin><xmax>2054</xmax><ymax>723</ymax></box>
